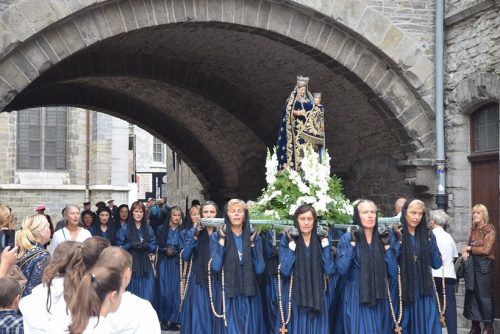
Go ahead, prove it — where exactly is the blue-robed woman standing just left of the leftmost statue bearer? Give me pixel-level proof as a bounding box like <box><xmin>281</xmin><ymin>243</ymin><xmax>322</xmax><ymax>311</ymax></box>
<box><xmin>156</xmin><ymin>206</ymin><xmax>184</xmax><ymax>330</ymax></box>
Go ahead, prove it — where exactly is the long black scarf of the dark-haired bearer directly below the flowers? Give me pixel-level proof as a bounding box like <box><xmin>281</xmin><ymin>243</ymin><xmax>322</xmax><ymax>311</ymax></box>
<box><xmin>293</xmin><ymin>205</ymin><xmax>324</xmax><ymax>312</ymax></box>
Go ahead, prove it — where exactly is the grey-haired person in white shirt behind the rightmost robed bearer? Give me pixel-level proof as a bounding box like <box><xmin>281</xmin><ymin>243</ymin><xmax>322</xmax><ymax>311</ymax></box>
<box><xmin>429</xmin><ymin>210</ymin><xmax>458</xmax><ymax>334</ymax></box>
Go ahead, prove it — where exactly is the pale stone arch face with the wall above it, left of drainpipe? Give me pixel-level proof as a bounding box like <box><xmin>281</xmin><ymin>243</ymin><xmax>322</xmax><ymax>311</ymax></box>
<box><xmin>0</xmin><ymin>0</ymin><xmax>433</xmax><ymax>157</ymax></box>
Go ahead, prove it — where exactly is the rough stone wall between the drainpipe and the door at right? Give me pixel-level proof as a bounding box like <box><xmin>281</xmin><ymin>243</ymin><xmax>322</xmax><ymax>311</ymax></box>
<box><xmin>445</xmin><ymin>1</ymin><xmax>500</xmax><ymax>246</ymax></box>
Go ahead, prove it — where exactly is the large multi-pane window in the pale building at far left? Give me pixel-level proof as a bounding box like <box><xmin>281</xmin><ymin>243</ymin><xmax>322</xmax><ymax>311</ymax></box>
<box><xmin>17</xmin><ymin>107</ymin><xmax>67</xmax><ymax>171</ymax></box>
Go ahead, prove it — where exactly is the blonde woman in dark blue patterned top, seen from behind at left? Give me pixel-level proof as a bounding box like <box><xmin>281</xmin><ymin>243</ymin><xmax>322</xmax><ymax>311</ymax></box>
<box><xmin>16</xmin><ymin>214</ymin><xmax>50</xmax><ymax>297</ymax></box>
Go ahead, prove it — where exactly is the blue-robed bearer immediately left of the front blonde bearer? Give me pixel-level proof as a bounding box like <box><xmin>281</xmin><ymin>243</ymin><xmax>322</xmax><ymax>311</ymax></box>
<box><xmin>181</xmin><ymin>201</ymin><xmax>224</xmax><ymax>334</ymax></box>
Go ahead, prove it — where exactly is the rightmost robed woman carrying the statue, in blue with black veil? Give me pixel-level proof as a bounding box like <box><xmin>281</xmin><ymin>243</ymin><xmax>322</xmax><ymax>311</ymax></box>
<box><xmin>394</xmin><ymin>199</ymin><xmax>442</xmax><ymax>334</ymax></box>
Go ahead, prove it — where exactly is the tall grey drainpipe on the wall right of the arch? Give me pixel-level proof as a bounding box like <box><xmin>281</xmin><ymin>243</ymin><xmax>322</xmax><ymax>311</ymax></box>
<box><xmin>435</xmin><ymin>0</ymin><xmax>448</xmax><ymax>210</ymax></box>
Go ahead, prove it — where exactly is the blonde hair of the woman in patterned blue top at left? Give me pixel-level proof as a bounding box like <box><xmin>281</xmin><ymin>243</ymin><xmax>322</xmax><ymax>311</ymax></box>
<box><xmin>16</xmin><ymin>214</ymin><xmax>50</xmax><ymax>258</ymax></box>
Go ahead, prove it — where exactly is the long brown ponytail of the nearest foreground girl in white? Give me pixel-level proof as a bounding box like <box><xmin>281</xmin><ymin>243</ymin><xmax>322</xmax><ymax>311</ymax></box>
<box><xmin>69</xmin><ymin>266</ymin><xmax>123</xmax><ymax>334</ymax></box>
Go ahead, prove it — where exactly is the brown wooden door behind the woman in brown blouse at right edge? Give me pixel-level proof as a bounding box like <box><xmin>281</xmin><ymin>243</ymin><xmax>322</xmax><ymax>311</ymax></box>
<box><xmin>470</xmin><ymin>152</ymin><xmax>500</xmax><ymax>318</ymax></box>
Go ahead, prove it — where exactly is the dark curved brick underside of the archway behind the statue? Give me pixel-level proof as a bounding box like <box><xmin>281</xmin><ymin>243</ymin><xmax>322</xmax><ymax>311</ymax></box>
<box><xmin>5</xmin><ymin>24</ymin><xmax>418</xmax><ymax>198</ymax></box>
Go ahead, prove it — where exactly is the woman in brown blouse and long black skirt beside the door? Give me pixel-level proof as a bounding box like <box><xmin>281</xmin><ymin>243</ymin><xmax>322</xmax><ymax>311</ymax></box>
<box><xmin>462</xmin><ymin>204</ymin><xmax>496</xmax><ymax>334</ymax></box>
